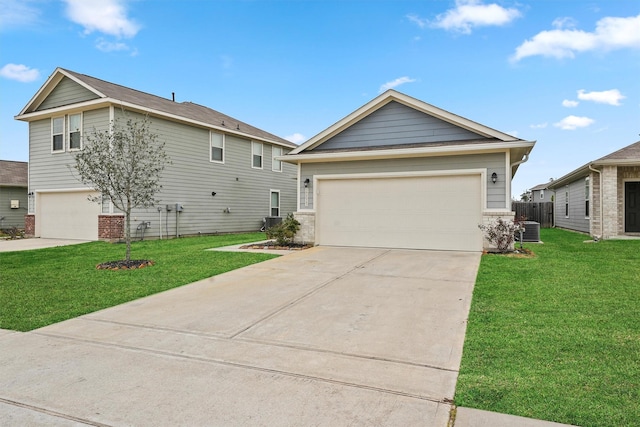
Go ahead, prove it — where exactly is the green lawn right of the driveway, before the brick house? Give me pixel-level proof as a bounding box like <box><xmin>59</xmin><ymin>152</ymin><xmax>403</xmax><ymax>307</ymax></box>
<box><xmin>455</xmin><ymin>229</ymin><xmax>640</xmax><ymax>427</ymax></box>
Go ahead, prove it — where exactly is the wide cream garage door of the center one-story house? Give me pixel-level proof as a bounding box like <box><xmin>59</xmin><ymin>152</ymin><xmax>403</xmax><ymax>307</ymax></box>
<box><xmin>316</xmin><ymin>175</ymin><xmax>482</xmax><ymax>251</ymax></box>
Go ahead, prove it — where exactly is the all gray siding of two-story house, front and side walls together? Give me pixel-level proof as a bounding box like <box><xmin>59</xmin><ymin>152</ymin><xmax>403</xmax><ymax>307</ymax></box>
<box><xmin>29</xmin><ymin>108</ymin><xmax>296</xmax><ymax>238</ymax></box>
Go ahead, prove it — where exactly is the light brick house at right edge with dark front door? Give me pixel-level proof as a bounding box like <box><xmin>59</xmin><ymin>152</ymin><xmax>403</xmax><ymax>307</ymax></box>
<box><xmin>549</xmin><ymin>141</ymin><xmax>640</xmax><ymax>239</ymax></box>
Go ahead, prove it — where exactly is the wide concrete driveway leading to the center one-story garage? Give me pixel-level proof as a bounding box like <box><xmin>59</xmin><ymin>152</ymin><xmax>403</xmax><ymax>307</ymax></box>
<box><xmin>0</xmin><ymin>247</ymin><xmax>480</xmax><ymax>427</ymax></box>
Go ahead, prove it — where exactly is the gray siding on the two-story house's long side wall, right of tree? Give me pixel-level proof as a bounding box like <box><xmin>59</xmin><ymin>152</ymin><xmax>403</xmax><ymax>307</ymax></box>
<box><xmin>112</xmin><ymin>110</ymin><xmax>296</xmax><ymax>237</ymax></box>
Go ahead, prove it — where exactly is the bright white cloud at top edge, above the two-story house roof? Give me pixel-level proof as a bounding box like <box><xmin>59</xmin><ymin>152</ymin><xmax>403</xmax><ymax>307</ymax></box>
<box><xmin>65</xmin><ymin>0</ymin><xmax>140</xmax><ymax>37</ymax></box>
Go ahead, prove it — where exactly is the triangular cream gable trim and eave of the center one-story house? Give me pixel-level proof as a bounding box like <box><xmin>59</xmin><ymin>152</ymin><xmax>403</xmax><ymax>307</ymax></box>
<box><xmin>283</xmin><ymin>90</ymin><xmax>535</xmax><ymax>173</ymax></box>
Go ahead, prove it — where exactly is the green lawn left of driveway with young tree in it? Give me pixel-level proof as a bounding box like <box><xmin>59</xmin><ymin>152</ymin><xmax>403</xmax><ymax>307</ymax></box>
<box><xmin>0</xmin><ymin>233</ymin><xmax>274</xmax><ymax>331</ymax></box>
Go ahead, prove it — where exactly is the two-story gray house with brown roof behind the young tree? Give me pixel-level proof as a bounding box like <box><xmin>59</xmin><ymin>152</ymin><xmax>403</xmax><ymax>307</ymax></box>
<box><xmin>16</xmin><ymin>68</ymin><xmax>296</xmax><ymax>240</ymax></box>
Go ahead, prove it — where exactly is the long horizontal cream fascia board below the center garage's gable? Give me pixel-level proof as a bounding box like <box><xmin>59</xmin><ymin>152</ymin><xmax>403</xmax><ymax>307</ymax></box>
<box><xmin>277</xmin><ymin>141</ymin><xmax>535</xmax><ymax>163</ymax></box>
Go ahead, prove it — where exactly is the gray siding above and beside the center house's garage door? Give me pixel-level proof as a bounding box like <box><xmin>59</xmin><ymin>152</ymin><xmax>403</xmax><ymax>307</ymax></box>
<box><xmin>300</xmin><ymin>153</ymin><xmax>507</xmax><ymax>209</ymax></box>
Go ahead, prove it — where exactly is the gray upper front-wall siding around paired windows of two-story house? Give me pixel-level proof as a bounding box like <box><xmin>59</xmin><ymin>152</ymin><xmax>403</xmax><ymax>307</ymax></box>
<box><xmin>29</xmin><ymin>108</ymin><xmax>109</xmax><ymax>191</ymax></box>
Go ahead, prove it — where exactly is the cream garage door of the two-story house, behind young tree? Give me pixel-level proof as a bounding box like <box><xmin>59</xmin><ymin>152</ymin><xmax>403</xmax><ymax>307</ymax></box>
<box><xmin>36</xmin><ymin>191</ymin><xmax>100</xmax><ymax>240</ymax></box>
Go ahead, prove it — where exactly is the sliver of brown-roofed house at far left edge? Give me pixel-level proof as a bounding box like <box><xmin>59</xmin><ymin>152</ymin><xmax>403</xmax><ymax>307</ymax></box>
<box><xmin>0</xmin><ymin>160</ymin><xmax>29</xmax><ymax>229</ymax></box>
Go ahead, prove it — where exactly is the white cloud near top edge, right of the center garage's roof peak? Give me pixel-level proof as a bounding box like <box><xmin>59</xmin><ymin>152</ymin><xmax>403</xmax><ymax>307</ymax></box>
<box><xmin>431</xmin><ymin>0</ymin><xmax>522</xmax><ymax>34</ymax></box>
